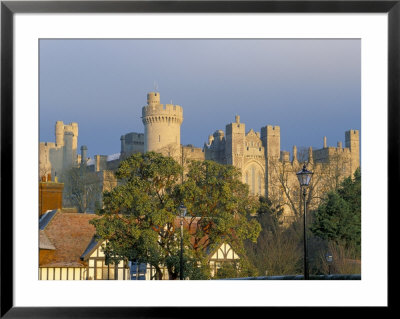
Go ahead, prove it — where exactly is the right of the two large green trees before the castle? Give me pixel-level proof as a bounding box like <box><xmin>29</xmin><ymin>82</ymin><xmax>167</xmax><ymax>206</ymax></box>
<box><xmin>176</xmin><ymin>161</ymin><xmax>261</xmax><ymax>260</ymax></box>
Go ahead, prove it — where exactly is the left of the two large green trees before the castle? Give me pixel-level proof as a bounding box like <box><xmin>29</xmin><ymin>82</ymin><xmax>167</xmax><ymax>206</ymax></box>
<box><xmin>93</xmin><ymin>152</ymin><xmax>181</xmax><ymax>279</ymax></box>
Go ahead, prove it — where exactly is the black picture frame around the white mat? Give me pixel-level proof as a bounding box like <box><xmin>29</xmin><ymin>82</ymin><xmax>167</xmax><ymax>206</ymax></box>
<box><xmin>0</xmin><ymin>0</ymin><xmax>394</xmax><ymax>318</ymax></box>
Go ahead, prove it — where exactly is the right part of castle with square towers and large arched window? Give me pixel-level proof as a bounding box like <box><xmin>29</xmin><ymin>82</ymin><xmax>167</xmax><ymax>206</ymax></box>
<box><xmin>204</xmin><ymin>116</ymin><xmax>360</xmax><ymax>219</ymax></box>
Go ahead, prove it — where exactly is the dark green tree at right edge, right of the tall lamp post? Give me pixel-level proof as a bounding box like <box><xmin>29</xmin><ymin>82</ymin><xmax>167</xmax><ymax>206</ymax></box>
<box><xmin>310</xmin><ymin>169</ymin><xmax>361</xmax><ymax>253</ymax></box>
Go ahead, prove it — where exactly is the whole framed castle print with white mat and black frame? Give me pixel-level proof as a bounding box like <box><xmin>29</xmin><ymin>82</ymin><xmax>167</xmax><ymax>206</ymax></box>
<box><xmin>1</xmin><ymin>1</ymin><xmax>400</xmax><ymax>318</ymax></box>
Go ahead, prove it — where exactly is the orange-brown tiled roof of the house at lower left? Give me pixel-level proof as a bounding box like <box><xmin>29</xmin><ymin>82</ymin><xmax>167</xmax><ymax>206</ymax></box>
<box><xmin>40</xmin><ymin>210</ymin><xmax>98</xmax><ymax>267</ymax></box>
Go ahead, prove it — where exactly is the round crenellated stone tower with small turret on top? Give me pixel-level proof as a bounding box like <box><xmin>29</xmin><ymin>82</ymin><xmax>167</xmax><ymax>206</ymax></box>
<box><xmin>142</xmin><ymin>92</ymin><xmax>183</xmax><ymax>156</ymax></box>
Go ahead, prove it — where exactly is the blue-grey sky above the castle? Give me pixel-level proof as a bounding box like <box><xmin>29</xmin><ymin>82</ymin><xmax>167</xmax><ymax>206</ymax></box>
<box><xmin>39</xmin><ymin>39</ymin><xmax>361</xmax><ymax>157</ymax></box>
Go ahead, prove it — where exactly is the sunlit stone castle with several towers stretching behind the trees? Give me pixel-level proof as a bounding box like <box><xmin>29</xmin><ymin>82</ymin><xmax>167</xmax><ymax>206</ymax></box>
<box><xmin>40</xmin><ymin>92</ymin><xmax>360</xmax><ymax>216</ymax></box>
